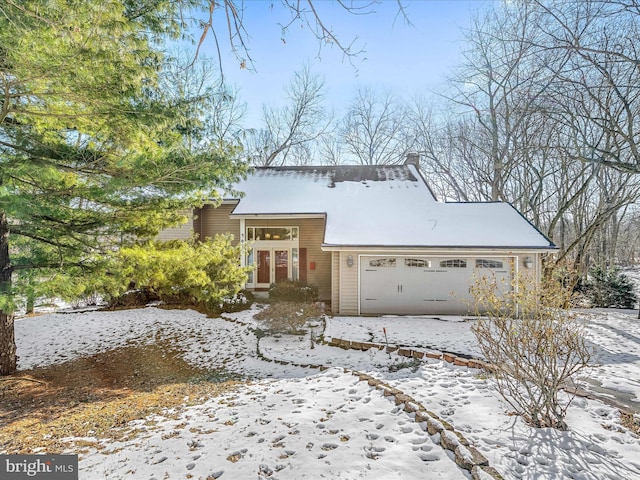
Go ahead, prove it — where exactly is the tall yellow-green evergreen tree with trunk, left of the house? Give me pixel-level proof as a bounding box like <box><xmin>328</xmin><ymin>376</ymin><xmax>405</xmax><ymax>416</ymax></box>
<box><xmin>0</xmin><ymin>0</ymin><xmax>243</xmax><ymax>375</ymax></box>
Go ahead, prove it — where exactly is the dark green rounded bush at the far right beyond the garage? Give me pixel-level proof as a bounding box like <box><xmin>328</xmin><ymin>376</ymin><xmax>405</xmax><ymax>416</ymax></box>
<box><xmin>577</xmin><ymin>266</ymin><xmax>637</xmax><ymax>308</ymax></box>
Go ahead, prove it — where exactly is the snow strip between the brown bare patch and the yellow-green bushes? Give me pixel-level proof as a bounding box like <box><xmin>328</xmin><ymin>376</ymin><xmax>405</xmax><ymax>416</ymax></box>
<box><xmin>16</xmin><ymin>307</ymin><xmax>309</xmax><ymax>378</ymax></box>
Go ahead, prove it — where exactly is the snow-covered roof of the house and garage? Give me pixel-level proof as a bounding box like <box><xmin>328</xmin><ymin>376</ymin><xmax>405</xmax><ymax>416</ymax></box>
<box><xmin>226</xmin><ymin>165</ymin><xmax>555</xmax><ymax>249</ymax></box>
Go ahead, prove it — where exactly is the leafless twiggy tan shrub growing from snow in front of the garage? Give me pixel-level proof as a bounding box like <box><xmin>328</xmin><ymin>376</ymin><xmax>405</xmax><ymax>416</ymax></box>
<box><xmin>472</xmin><ymin>277</ymin><xmax>593</xmax><ymax>430</ymax></box>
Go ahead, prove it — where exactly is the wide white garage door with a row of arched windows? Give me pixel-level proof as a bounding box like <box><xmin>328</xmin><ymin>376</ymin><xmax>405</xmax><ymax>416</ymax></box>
<box><xmin>360</xmin><ymin>256</ymin><xmax>511</xmax><ymax>315</ymax></box>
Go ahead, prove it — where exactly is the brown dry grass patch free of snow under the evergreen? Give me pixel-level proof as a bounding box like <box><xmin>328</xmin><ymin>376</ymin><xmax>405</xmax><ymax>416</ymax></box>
<box><xmin>0</xmin><ymin>340</ymin><xmax>239</xmax><ymax>454</ymax></box>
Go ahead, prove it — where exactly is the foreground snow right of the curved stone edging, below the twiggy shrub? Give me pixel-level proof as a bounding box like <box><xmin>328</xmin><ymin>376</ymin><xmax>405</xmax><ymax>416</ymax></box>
<box><xmin>385</xmin><ymin>364</ymin><xmax>640</xmax><ymax>480</ymax></box>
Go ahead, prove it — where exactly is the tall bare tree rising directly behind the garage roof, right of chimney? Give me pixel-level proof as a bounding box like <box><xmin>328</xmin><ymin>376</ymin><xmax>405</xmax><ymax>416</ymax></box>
<box><xmin>448</xmin><ymin>3</ymin><xmax>552</xmax><ymax>201</ymax></box>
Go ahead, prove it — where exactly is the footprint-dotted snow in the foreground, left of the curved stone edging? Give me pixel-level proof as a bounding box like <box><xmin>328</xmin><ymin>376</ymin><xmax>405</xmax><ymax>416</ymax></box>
<box><xmin>81</xmin><ymin>369</ymin><xmax>466</xmax><ymax>479</ymax></box>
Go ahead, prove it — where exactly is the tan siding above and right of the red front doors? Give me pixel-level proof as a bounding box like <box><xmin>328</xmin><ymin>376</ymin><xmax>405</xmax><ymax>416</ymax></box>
<box><xmin>246</xmin><ymin>218</ymin><xmax>331</xmax><ymax>301</ymax></box>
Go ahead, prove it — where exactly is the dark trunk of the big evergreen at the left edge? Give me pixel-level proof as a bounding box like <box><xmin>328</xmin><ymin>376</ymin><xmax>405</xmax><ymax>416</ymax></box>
<box><xmin>0</xmin><ymin>211</ymin><xmax>18</xmax><ymax>375</ymax></box>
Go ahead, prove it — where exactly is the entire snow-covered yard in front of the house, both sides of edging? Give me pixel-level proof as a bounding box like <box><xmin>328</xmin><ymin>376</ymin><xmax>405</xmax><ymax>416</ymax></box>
<box><xmin>5</xmin><ymin>308</ymin><xmax>640</xmax><ymax>480</ymax></box>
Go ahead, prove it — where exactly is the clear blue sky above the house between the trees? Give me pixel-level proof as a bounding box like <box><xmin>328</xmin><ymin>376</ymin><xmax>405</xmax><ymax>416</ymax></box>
<box><xmin>198</xmin><ymin>0</ymin><xmax>487</xmax><ymax>127</ymax></box>
